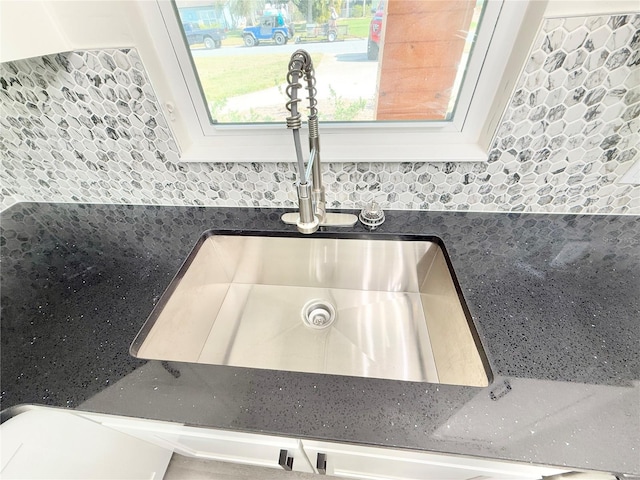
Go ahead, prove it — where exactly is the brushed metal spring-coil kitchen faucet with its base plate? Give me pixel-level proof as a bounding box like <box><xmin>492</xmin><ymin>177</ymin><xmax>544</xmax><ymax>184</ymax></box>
<box><xmin>282</xmin><ymin>50</ymin><xmax>358</xmax><ymax>233</ymax></box>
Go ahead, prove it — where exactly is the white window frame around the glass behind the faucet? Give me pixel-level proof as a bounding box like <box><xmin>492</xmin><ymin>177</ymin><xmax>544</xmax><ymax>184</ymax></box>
<box><xmin>140</xmin><ymin>0</ymin><xmax>546</xmax><ymax>162</ymax></box>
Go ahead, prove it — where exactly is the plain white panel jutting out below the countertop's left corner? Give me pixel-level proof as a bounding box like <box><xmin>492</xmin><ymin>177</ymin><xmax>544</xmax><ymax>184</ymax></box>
<box><xmin>0</xmin><ymin>408</ymin><xmax>173</xmax><ymax>480</ymax></box>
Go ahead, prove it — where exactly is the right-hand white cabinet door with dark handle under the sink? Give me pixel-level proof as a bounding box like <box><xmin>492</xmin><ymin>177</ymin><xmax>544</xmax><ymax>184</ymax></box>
<box><xmin>302</xmin><ymin>440</ymin><xmax>567</xmax><ymax>480</ymax></box>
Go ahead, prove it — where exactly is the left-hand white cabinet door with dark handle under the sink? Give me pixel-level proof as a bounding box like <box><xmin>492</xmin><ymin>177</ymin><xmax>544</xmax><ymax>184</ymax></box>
<box><xmin>83</xmin><ymin>413</ymin><xmax>314</xmax><ymax>473</ymax></box>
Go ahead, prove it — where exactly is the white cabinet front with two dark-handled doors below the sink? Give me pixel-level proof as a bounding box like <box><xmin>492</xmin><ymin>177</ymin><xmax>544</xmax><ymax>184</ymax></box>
<box><xmin>74</xmin><ymin>413</ymin><xmax>568</xmax><ymax>480</ymax></box>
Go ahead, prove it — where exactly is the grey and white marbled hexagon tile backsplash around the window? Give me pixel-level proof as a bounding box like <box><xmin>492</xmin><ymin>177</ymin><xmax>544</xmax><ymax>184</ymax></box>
<box><xmin>0</xmin><ymin>14</ymin><xmax>640</xmax><ymax>214</ymax></box>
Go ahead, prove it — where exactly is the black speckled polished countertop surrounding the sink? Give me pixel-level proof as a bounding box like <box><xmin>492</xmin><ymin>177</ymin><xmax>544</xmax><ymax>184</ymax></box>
<box><xmin>0</xmin><ymin>203</ymin><xmax>640</xmax><ymax>475</ymax></box>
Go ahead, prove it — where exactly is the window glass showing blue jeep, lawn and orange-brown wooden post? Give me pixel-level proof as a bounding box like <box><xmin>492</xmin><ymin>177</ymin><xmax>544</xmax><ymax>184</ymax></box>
<box><xmin>174</xmin><ymin>0</ymin><xmax>485</xmax><ymax>124</ymax></box>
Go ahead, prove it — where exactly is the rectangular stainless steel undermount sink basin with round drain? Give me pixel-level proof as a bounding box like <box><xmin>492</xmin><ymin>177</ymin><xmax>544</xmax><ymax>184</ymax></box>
<box><xmin>131</xmin><ymin>231</ymin><xmax>489</xmax><ymax>386</ymax></box>
